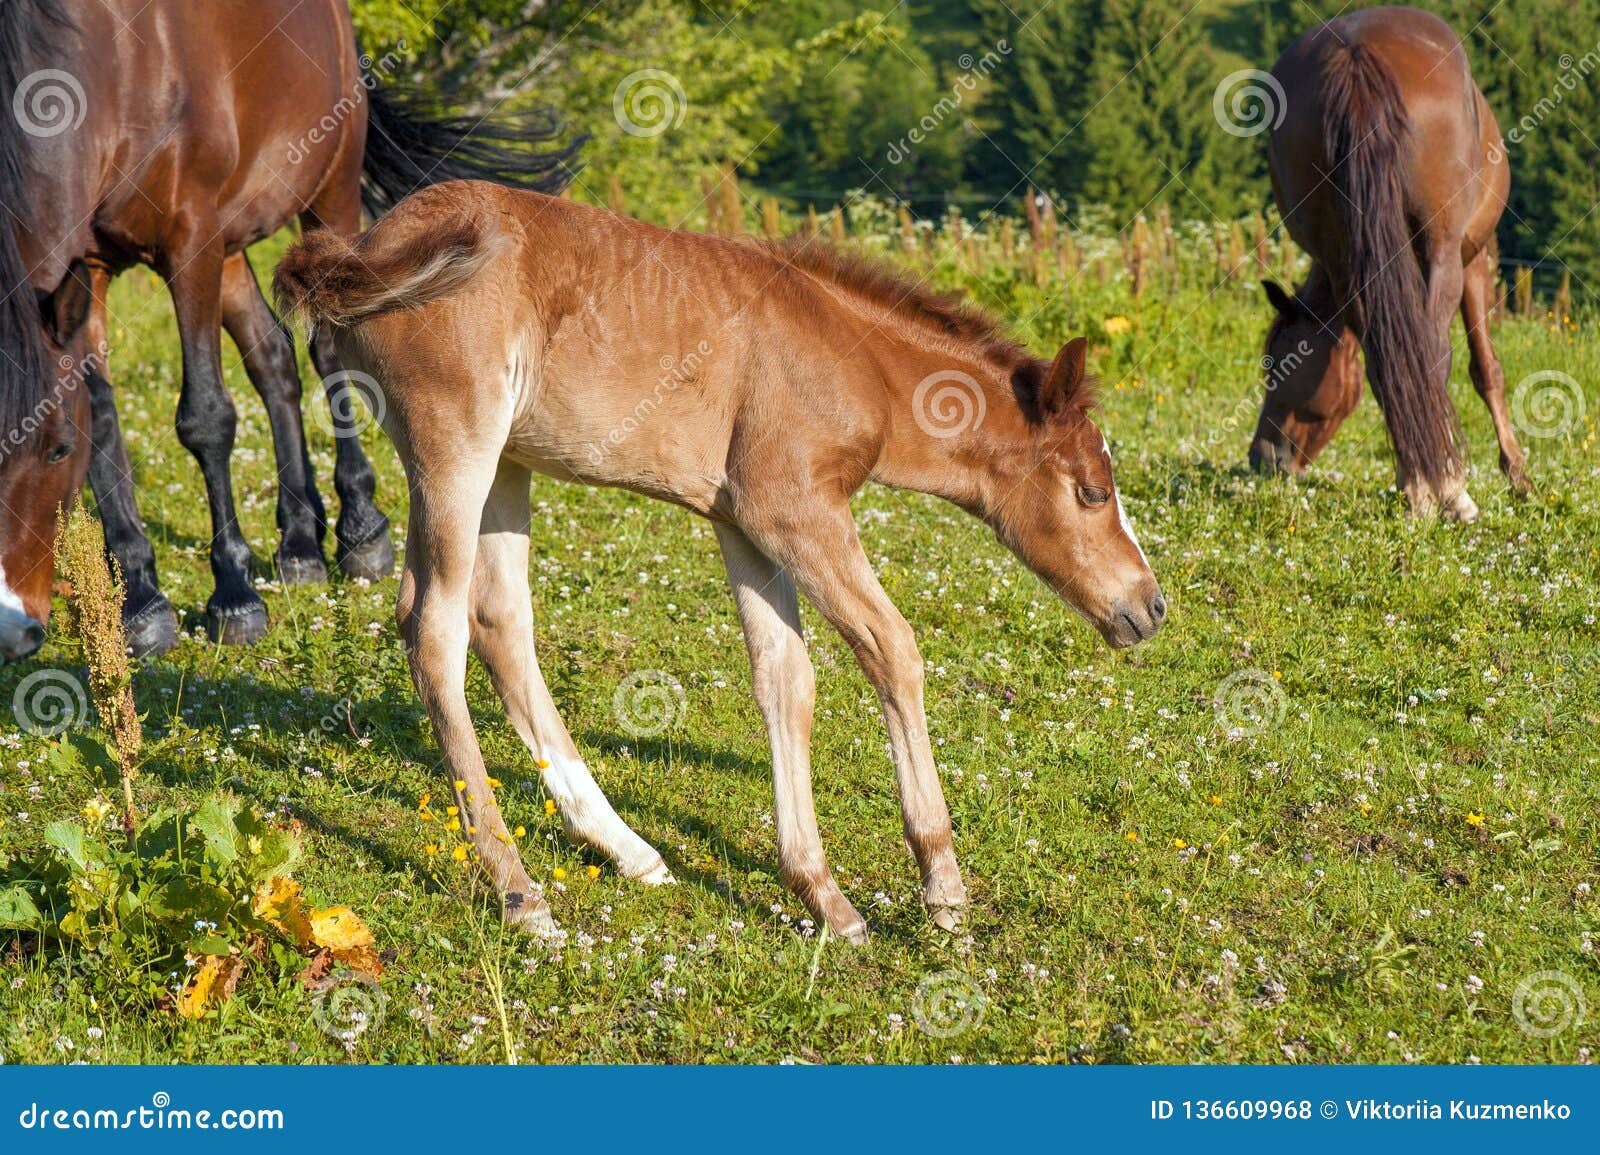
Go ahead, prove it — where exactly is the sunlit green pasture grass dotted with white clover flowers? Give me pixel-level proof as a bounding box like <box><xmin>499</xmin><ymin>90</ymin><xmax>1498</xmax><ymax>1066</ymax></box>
<box><xmin>0</xmin><ymin>217</ymin><xmax>1600</xmax><ymax>1064</ymax></box>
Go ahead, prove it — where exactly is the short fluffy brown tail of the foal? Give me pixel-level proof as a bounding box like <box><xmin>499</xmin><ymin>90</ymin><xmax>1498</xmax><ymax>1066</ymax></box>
<box><xmin>272</xmin><ymin>214</ymin><xmax>498</xmax><ymax>326</ymax></box>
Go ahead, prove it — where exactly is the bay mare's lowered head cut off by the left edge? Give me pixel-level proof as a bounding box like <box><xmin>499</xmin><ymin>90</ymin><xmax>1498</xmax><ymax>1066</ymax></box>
<box><xmin>0</xmin><ymin>261</ymin><xmax>93</xmax><ymax>661</ymax></box>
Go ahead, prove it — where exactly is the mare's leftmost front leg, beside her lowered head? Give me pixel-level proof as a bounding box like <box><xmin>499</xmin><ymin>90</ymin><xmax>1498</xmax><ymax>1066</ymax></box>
<box><xmin>85</xmin><ymin>267</ymin><xmax>178</xmax><ymax>657</ymax></box>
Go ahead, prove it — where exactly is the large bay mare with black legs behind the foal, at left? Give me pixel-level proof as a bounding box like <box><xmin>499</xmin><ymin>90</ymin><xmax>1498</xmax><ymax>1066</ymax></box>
<box><xmin>0</xmin><ymin>0</ymin><xmax>571</xmax><ymax>657</ymax></box>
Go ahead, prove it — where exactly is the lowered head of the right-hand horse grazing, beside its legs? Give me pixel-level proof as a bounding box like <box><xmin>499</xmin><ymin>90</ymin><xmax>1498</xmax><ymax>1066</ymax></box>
<box><xmin>1250</xmin><ymin>282</ymin><xmax>1362</xmax><ymax>474</ymax></box>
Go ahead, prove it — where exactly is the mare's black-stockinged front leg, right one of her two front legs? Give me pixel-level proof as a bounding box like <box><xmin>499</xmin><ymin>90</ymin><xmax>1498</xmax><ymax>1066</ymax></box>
<box><xmin>163</xmin><ymin>208</ymin><xmax>267</xmax><ymax>645</ymax></box>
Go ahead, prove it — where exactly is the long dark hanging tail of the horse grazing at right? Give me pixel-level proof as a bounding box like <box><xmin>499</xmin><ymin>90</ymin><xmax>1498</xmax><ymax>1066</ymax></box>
<box><xmin>1323</xmin><ymin>43</ymin><xmax>1461</xmax><ymax>496</ymax></box>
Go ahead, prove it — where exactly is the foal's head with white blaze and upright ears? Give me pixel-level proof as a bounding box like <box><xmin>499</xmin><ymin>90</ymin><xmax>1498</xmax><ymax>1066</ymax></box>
<box><xmin>986</xmin><ymin>338</ymin><xmax>1166</xmax><ymax>648</ymax></box>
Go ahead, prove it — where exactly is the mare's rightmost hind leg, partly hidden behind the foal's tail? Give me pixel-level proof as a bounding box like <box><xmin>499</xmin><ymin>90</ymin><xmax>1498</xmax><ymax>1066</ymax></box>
<box><xmin>301</xmin><ymin>196</ymin><xmax>395</xmax><ymax>579</ymax></box>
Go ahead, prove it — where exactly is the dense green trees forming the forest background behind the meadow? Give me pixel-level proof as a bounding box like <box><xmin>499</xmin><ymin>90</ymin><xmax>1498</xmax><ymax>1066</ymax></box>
<box><xmin>354</xmin><ymin>0</ymin><xmax>1600</xmax><ymax>296</ymax></box>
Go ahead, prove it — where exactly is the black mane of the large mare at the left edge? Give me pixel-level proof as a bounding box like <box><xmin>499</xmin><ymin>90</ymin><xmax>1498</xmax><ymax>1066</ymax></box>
<box><xmin>0</xmin><ymin>0</ymin><xmax>72</xmax><ymax>432</ymax></box>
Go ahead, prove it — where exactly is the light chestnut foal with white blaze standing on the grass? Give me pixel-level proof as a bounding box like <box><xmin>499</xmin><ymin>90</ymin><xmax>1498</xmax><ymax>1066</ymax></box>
<box><xmin>275</xmin><ymin>182</ymin><xmax>1166</xmax><ymax>939</ymax></box>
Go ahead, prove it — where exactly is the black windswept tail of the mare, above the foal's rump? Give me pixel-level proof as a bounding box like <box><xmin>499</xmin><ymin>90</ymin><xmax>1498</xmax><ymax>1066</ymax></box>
<box><xmin>362</xmin><ymin>72</ymin><xmax>589</xmax><ymax>218</ymax></box>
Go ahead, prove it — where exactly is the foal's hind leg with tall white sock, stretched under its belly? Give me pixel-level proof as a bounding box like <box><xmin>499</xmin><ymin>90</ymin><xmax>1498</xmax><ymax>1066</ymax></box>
<box><xmin>472</xmin><ymin>461</ymin><xmax>672</xmax><ymax>883</ymax></box>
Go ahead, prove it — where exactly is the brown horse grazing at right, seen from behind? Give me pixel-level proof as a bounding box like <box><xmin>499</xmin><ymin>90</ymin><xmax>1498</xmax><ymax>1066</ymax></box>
<box><xmin>1250</xmin><ymin>8</ymin><xmax>1528</xmax><ymax>522</ymax></box>
